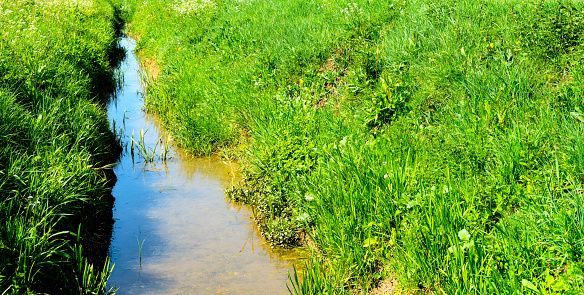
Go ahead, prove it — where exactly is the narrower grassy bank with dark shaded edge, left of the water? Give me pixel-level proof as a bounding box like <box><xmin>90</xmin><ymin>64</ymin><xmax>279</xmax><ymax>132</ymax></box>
<box><xmin>0</xmin><ymin>0</ymin><xmax>121</xmax><ymax>294</ymax></box>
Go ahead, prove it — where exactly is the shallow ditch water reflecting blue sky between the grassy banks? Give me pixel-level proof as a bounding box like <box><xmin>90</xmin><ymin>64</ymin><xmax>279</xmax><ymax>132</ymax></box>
<box><xmin>108</xmin><ymin>38</ymin><xmax>297</xmax><ymax>295</ymax></box>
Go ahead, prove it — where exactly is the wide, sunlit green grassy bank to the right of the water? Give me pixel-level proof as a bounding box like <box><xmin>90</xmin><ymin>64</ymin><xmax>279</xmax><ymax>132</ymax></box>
<box><xmin>120</xmin><ymin>0</ymin><xmax>584</xmax><ymax>294</ymax></box>
